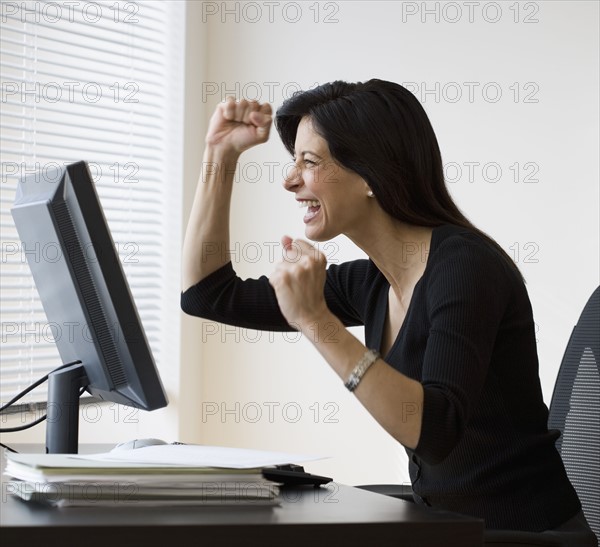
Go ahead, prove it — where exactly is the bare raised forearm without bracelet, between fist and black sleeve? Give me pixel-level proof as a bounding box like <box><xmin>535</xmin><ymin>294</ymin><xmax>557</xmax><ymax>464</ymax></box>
<box><xmin>182</xmin><ymin>145</ymin><xmax>239</xmax><ymax>291</ymax></box>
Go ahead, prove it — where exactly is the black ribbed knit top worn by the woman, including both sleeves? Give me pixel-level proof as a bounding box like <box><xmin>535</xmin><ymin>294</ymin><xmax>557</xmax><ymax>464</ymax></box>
<box><xmin>181</xmin><ymin>225</ymin><xmax>581</xmax><ymax>531</ymax></box>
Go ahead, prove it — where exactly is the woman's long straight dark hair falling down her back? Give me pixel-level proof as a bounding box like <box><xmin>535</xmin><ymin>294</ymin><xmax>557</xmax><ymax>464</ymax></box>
<box><xmin>275</xmin><ymin>79</ymin><xmax>520</xmax><ymax>275</ymax></box>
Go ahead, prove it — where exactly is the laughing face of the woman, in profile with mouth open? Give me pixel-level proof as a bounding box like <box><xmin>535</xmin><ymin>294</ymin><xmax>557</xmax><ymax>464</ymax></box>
<box><xmin>283</xmin><ymin>117</ymin><xmax>369</xmax><ymax>241</ymax></box>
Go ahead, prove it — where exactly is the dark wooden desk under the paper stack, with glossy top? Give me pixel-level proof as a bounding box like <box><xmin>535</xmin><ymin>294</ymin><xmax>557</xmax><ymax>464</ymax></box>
<box><xmin>0</xmin><ymin>447</ymin><xmax>483</xmax><ymax>547</ymax></box>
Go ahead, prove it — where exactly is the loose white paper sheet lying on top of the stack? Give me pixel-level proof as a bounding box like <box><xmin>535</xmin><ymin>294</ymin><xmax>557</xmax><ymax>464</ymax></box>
<box><xmin>70</xmin><ymin>444</ymin><xmax>323</xmax><ymax>469</ymax></box>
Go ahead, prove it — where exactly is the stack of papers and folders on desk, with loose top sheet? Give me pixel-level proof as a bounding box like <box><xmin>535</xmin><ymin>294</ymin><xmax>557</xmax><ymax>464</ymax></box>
<box><xmin>5</xmin><ymin>445</ymin><xmax>324</xmax><ymax>507</ymax></box>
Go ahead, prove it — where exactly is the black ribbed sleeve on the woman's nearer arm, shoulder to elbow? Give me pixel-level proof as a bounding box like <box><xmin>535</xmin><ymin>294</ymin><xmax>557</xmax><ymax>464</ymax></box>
<box><xmin>415</xmin><ymin>237</ymin><xmax>515</xmax><ymax>464</ymax></box>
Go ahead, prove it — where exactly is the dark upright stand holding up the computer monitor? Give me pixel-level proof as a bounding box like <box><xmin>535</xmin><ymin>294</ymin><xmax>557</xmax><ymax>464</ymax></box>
<box><xmin>46</xmin><ymin>363</ymin><xmax>89</xmax><ymax>454</ymax></box>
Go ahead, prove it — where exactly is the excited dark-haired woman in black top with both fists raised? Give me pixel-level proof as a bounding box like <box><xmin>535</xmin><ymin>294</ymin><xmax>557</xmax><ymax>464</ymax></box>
<box><xmin>181</xmin><ymin>80</ymin><xmax>586</xmax><ymax>531</ymax></box>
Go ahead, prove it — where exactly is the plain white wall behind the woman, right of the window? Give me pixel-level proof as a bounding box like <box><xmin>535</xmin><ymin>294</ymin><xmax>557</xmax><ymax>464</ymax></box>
<box><xmin>182</xmin><ymin>1</ymin><xmax>599</xmax><ymax>484</ymax></box>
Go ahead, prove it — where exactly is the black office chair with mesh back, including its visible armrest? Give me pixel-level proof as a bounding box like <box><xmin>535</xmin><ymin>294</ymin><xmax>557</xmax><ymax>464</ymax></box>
<box><xmin>358</xmin><ymin>287</ymin><xmax>600</xmax><ymax>547</ymax></box>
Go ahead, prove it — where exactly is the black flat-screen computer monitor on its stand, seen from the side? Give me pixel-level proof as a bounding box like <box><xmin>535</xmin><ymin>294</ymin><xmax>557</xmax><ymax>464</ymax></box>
<box><xmin>11</xmin><ymin>162</ymin><xmax>167</xmax><ymax>453</ymax></box>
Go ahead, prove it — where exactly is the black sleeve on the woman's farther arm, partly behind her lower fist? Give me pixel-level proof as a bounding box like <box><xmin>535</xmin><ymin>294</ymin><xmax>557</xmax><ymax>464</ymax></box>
<box><xmin>181</xmin><ymin>260</ymin><xmax>368</xmax><ymax>331</ymax></box>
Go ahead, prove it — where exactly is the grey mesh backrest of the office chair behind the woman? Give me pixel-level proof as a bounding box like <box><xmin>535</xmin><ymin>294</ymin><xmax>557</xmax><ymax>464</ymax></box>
<box><xmin>548</xmin><ymin>287</ymin><xmax>600</xmax><ymax>536</ymax></box>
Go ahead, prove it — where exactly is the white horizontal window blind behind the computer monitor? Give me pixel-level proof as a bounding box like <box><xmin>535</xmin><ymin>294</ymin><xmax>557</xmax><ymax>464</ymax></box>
<box><xmin>0</xmin><ymin>0</ymin><xmax>185</xmax><ymax>402</ymax></box>
